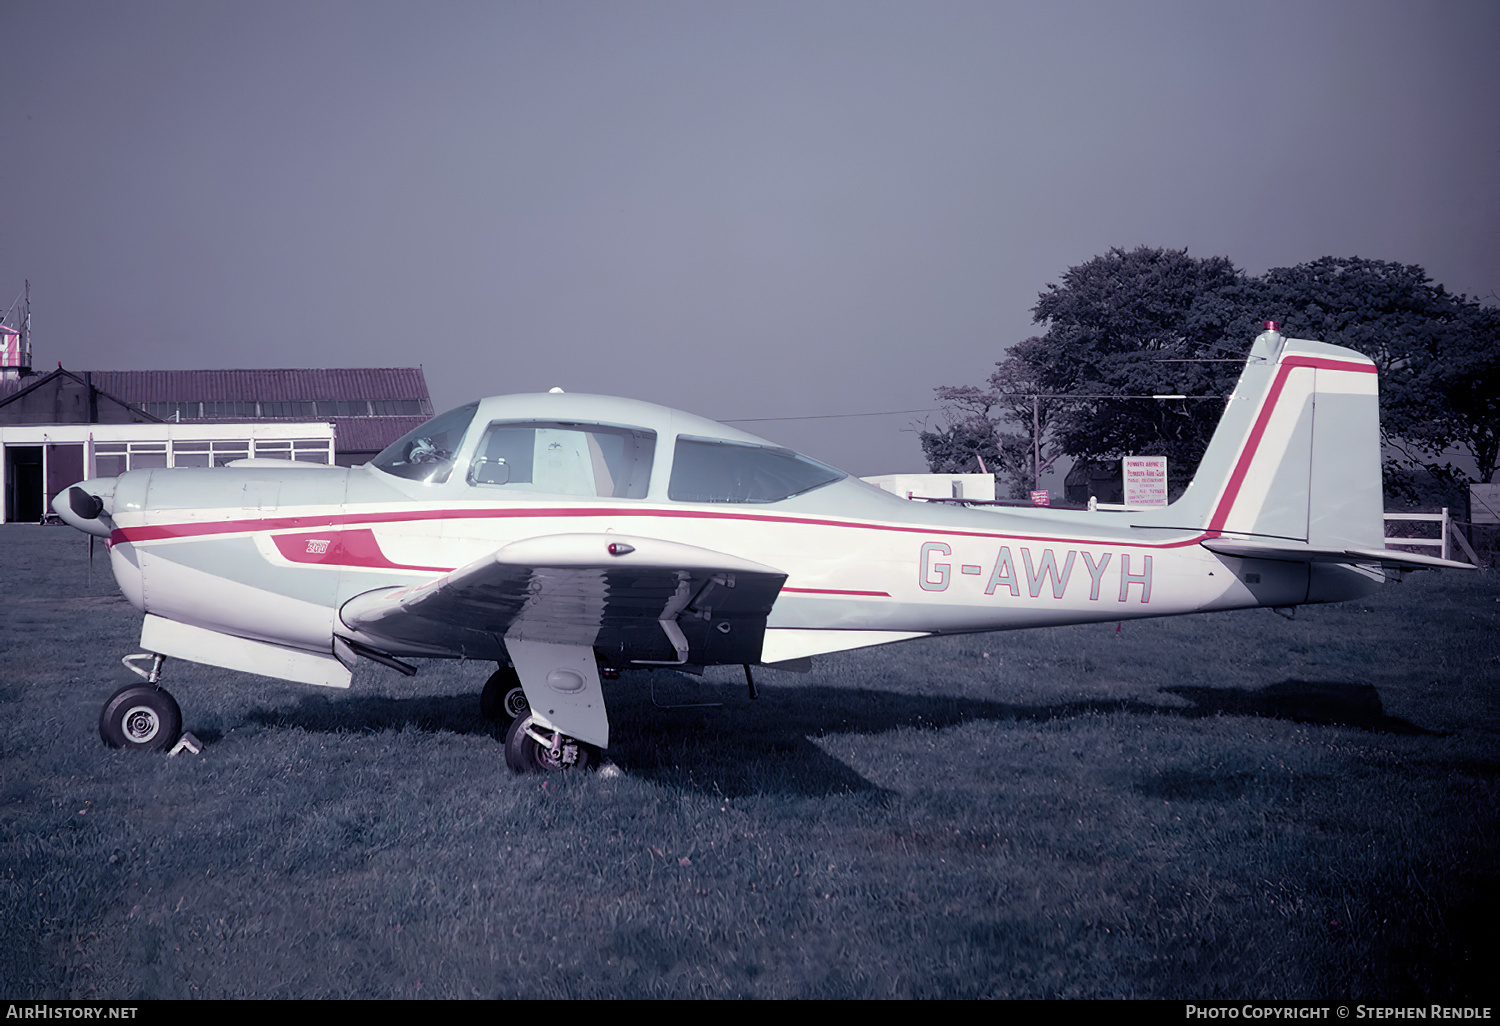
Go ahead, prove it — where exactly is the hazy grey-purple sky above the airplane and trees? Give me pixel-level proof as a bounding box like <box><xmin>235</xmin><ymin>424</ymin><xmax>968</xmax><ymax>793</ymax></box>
<box><xmin>0</xmin><ymin>0</ymin><xmax>1500</xmax><ymax>474</ymax></box>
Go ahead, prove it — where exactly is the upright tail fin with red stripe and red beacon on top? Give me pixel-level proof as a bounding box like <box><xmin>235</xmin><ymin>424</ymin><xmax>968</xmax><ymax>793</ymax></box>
<box><xmin>1173</xmin><ymin>323</ymin><xmax>1385</xmax><ymax>551</ymax></box>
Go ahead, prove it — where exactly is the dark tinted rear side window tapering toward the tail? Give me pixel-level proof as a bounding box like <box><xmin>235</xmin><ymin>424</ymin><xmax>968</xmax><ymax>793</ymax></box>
<box><xmin>668</xmin><ymin>435</ymin><xmax>846</xmax><ymax>503</ymax></box>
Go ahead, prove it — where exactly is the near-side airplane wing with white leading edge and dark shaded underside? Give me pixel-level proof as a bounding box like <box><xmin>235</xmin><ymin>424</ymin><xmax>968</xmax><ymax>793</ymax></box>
<box><xmin>339</xmin><ymin>533</ymin><xmax>786</xmax><ymax>665</ymax></box>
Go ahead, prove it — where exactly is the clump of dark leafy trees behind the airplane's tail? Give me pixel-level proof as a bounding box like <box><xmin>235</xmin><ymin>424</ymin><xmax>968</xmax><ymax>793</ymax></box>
<box><xmin>924</xmin><ymin>246</ymin><xmax>1500</xmax><ymax>504</ymax></box>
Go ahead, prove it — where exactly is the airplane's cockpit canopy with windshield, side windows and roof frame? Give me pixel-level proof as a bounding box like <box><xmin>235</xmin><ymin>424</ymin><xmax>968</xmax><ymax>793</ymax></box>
<box><xmin>371</xmin><ymin>396</ymin><xmax>845</xmax><ymax>503</ymax></box>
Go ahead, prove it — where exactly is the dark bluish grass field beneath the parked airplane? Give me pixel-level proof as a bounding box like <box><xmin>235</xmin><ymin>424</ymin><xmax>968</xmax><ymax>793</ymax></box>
<box><xmin>0</xmin><ymin>525</ymin><xmax>1500</xmax><ymax>1001</ymax></box>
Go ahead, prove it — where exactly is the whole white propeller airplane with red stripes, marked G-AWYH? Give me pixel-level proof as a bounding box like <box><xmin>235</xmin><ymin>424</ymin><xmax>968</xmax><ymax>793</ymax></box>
<box><xmin>54</xmin><ymin>323</ymin><xmax>1466</xmax><ymax>770</ymax></box>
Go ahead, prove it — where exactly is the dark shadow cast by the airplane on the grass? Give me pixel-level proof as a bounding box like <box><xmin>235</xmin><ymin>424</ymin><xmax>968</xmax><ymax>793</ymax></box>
<box><xmin>225</xmin><ymin>674</ymin><xmax>1433</xmax><ymax>797</ymax></box>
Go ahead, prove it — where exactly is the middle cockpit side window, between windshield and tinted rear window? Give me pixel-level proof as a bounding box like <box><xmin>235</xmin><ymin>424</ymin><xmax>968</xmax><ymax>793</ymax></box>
<box><xmin>468</xmin><ymin>420</ymin><xmax>656</xmax><ymax>498</ymax></box>
